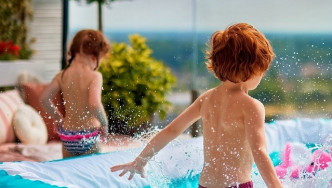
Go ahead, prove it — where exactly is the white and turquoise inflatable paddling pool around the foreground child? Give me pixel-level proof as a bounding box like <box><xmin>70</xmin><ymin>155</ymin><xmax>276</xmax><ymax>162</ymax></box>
<box><xmin>0</xmin><ymin>119</ymin><xmax>332</xmax><ymax>188</ymax></box>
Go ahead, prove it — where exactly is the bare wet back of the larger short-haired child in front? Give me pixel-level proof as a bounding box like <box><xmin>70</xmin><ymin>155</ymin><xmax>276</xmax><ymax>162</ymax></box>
<box><xmin>200</xmin><ymin>86</ymin><xmax>253</xmax><ymax>187</ymax></box>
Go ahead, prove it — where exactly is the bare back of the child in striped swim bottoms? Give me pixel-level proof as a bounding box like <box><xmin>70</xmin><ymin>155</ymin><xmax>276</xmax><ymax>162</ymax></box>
<box><xmin>58</xmin><ymin>64</ymin><xmax>100</xmax><ymax>131</ymax></box>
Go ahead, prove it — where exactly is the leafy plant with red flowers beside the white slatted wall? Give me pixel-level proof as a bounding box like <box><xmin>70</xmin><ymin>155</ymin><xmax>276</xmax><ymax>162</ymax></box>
<box><xmin>0</xmin><ymin>0</ymin><xmax>34</xmax><ymax>60</ymax></box>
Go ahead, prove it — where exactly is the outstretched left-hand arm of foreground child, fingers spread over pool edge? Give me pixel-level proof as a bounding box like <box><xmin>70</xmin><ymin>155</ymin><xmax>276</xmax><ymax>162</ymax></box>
<box><xmin>111</xmin><ymin>95</ymin><xmax>203</xmax><ymax>180</ymax></box>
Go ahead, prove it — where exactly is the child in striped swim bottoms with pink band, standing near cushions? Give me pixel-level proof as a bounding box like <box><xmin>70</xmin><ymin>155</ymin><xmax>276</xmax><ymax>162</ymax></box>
<box><xmin>41</xmin><ymin>30</ymin><xmax>110</xmax><ymax>158</ymax></box>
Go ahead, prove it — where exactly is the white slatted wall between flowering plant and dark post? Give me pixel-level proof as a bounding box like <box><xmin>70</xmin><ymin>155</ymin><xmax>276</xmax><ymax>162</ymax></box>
<box><xmin>28</xmin><ymin>0</ymin><xmax>62</xmax><ymax>81</ymax></box>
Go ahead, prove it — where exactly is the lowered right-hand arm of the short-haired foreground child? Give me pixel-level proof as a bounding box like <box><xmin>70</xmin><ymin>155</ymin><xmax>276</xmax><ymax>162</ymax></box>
<box><xmin>244</xmin><ymin>100</ymin><xmax>282</xmax><ymax>187</ymax></box>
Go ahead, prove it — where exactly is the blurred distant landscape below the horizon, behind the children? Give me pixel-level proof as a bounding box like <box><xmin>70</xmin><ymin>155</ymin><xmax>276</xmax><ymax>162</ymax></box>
<box><xmin>105</xmin><ymin>31</ymin><xmax>332</xmax><ymax>122</ymax></box>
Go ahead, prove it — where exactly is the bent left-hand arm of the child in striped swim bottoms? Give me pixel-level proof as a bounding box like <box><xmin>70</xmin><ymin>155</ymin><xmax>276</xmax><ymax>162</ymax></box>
<box><xmin>40</xmin><ymin>74</ymin><xmax>63</xmax><ymax>126</ymax></box>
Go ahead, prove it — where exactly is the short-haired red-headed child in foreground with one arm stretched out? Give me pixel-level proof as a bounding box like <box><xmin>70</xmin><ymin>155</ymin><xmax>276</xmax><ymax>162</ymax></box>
<box><xmin>111</xmin><ymin>23</ymin><xmax>282</xmax><ymax>188</ymax></box>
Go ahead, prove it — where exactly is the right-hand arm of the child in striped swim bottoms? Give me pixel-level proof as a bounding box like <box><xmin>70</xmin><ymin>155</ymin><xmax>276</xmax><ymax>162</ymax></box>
<box><xmin>89</xmin><ymin>72</ymin><xmax>108</xmax><ymax>136</ymax></box>
